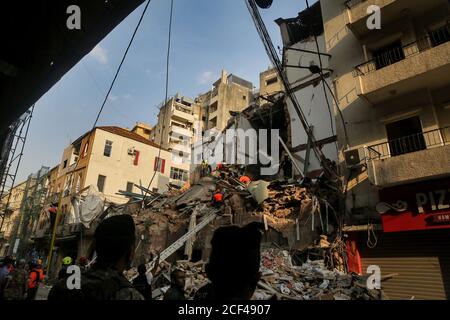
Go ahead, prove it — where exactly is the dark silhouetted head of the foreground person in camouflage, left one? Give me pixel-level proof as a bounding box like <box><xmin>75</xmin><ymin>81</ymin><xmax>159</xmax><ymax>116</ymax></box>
<box><xmin>95</xmin><ymin>214</ymin><xmax>136</xmax><ymax>272</ymax></box>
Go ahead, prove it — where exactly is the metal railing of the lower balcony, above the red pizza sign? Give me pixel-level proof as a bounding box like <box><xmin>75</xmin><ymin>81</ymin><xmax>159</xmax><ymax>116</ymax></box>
<box><xmin>367</xmin><ymin>127</ymin><xmax>450</xmax><ymax>160</ymax></box>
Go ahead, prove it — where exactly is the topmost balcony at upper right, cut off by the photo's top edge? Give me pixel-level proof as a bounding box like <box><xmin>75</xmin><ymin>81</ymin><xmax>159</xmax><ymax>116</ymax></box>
<box><xmin>345</xmin><ymin>0</ymin><xmax>446</xmax><ymax>38</ymax></box>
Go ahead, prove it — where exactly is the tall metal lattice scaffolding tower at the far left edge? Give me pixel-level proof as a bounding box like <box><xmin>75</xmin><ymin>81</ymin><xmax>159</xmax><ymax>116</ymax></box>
<box><xmin>0</xmin><ymin>105</ymin><xmax>34</xmax><ymax>230</ymax></box>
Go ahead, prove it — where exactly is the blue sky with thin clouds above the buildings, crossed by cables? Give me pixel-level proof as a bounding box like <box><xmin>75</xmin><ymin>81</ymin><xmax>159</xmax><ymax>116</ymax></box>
<box><xmin>16</xmin><ymin>0</ymin><xmax>305</xmax><ymax>182</ymax></box>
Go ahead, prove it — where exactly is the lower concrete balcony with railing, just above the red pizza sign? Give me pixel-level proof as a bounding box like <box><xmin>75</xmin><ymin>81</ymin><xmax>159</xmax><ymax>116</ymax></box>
<box><xmin>366</xmin><ymin>127</ymin><xmax>450</xmax><ymax>187</ymax></box>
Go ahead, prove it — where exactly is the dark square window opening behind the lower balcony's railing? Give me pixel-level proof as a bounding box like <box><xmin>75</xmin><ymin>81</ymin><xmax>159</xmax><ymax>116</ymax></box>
<box><xmin>386</xmin><ymin>117</ymin><xmax>426</xmax><ymax>157</ymax></box>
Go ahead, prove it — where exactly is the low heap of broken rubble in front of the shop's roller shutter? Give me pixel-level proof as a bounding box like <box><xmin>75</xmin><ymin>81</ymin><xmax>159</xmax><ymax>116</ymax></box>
<box><xmin>254</xmin><ymin>249</ymin><xmax>386</xmax><ymax>300</ymax></box>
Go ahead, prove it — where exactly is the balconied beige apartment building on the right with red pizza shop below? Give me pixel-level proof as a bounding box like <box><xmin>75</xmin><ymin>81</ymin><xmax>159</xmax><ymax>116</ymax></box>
<box><xmin>320</xmin><ymin>0</ymin><xmax>450</xmax><ymax>299</ymax></box>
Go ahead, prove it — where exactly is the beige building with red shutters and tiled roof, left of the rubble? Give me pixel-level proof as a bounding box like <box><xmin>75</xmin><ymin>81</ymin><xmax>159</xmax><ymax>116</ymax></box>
<box><xmin>34</xmin><ymin>126</ymin><xmax>172</xmax><ymax>270</ymax></box>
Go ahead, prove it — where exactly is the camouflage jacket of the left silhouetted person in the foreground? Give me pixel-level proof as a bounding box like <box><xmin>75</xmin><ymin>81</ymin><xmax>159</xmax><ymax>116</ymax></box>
<box><xmin>48</xmin><ymin>268</ymin><xmax>144</xmax><ymax>301</ymax></box>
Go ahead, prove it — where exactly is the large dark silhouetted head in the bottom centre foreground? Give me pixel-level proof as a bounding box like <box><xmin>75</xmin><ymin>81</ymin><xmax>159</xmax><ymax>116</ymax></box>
<box><xmin>206</xmin><ymin>223</ymin><xmax>262</xmax><ymax>300</ymax></box>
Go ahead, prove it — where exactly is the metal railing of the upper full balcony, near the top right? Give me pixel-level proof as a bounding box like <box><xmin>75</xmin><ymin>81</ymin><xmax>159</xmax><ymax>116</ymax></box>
<box><xmin>353</xmin><ymin>24</ymin><xmax>450</xmax><ymax>77</ymax></box>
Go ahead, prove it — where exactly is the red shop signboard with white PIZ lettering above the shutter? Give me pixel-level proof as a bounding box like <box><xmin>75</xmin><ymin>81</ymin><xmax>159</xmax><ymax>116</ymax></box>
<box><xmin>377</xmin><ymin>179</ymin><xmax>450</xmax><ymax>232</ymax></box>
